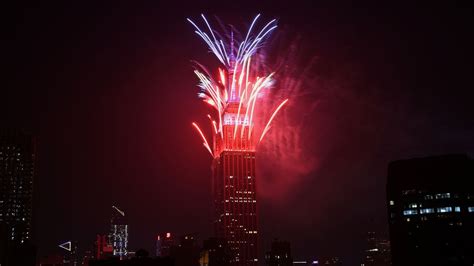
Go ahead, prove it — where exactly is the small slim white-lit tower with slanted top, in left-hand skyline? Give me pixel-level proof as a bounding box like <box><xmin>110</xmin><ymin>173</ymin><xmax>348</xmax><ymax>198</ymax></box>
<box><xmin>109</xmin><ymin>206</ymin><xmax>128</xmax><ymax>259</ymax></box>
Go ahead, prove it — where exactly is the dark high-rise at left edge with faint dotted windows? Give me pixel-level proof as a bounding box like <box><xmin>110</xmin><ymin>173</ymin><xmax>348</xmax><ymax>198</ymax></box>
<box><xmin>0</xmin><ymin>130</ymin><xmax>35</xmax><ymax>265</ymax></box>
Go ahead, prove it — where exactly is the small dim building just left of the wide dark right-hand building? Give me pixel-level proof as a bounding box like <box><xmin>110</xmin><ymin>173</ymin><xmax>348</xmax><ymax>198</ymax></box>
<box><xmin>362</xmin><ymin>232</ymin><xmax>392</xmax><ymax>266</ymax></box>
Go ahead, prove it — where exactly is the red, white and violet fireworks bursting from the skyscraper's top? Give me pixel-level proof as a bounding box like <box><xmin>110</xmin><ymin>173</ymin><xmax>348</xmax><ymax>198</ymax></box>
<box><xmin>188</xmin><ymin>14</ymin><xmax>288</xmax><ymax>157</ymax></box>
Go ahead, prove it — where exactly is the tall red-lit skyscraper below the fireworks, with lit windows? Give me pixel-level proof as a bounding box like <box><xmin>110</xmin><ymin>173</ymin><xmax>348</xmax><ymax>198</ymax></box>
<box><xmin>212</xmin><ymin>102</ymin><xmax>258</xmax><ymax>265</ymax></box>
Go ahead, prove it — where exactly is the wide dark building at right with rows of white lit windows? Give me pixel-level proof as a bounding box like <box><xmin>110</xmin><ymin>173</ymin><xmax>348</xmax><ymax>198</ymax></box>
<box><xmin>387</xmin><ymin>155</ymin><xmax>474</xmax><ymax>266</ymax></box>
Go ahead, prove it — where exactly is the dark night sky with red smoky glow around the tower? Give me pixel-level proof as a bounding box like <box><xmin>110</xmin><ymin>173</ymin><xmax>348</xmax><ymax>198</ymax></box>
<box><xmin>4</xmin><ymin>1</ymin><xmax>474</xmax><ymax>265</ymax></box>
